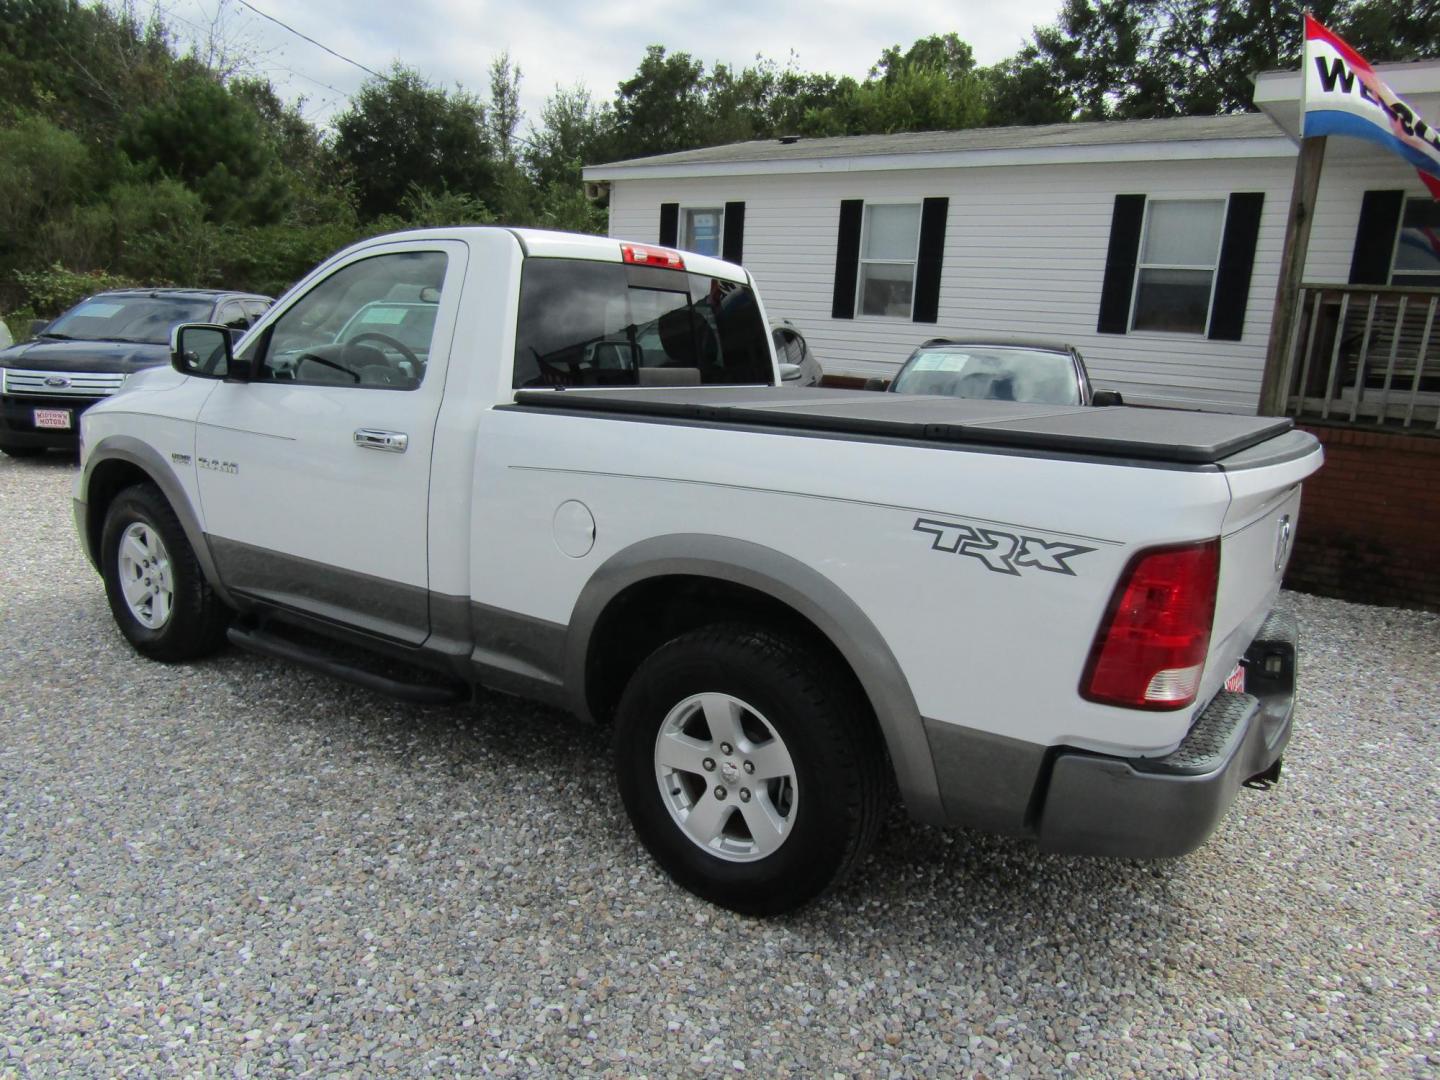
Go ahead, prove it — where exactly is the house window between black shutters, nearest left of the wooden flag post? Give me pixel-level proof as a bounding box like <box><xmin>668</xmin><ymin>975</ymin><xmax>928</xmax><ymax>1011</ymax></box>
<box><xmin>1130</xmin><ymin>199</ymin><xmax>1225</xmax><ymax>334</ymax></box>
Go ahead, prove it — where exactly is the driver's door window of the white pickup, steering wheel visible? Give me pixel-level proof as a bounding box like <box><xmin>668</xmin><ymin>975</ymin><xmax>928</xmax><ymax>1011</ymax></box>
<box><xmin>253</xmin><ymin>252</ymin><xmax>446</xmax><ymax>390</ymax></box>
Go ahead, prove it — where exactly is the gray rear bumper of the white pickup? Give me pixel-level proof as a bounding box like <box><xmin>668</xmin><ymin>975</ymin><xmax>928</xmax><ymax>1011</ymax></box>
<box><xmin>1037</xmin><ymin>615</ymin><xmax>1297</xmax><ymax>858</ymax></box>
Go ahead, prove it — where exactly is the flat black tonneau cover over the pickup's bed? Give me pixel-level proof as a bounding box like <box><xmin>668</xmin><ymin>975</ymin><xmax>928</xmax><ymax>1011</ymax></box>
<box><xmin>516</xmin><ymin>386</ymin><xmax>1309</xmax><ymax>465</ymax></box>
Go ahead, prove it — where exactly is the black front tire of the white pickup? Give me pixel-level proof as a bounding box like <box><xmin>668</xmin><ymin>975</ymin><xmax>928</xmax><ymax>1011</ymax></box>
<box><xmin>101</xmin><ymin>484</ymin><xmax>230</xmax><ymax>662</ymax></box>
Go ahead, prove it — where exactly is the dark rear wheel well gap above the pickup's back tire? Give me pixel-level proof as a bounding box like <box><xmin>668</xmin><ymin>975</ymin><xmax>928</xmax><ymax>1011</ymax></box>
<box><xmin>585</xmin><ymin>575</ymin><xmax>878</xmax><ymax>727</ymax></box>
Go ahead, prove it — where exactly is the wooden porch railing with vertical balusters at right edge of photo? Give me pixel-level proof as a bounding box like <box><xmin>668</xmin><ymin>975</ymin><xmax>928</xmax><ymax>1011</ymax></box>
<box><xmin>1282</xmin><ymin>284</ymin><xmax>1440</xmax><ymax>432</ymax></box>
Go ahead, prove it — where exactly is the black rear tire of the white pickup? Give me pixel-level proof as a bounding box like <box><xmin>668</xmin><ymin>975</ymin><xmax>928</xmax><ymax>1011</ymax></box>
<box><xmin>615</xmin><ymin>624</ymin><xmax>886</xmax><ymax>916</ymax></box>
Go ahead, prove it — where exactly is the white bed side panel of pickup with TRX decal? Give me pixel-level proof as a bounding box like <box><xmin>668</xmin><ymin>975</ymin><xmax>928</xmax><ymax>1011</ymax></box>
<box><xmin>471</xmin><ymin>409</ymin><xmax>1230</xmax><ymax>753</ymax></box>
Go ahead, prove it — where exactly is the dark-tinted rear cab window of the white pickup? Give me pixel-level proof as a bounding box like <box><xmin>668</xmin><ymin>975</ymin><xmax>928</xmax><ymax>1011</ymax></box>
<box><xmin>514</xmin><ymin>259</ymin><xmax>775</xmax><ymax>387</ymax></box>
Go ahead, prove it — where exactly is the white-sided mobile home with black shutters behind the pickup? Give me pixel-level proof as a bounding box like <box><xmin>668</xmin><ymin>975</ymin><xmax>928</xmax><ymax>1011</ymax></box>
<box><xmin>585</xmin><ymin>62</ymin><xmax>1440</xmax><ymax>412</ymax></box>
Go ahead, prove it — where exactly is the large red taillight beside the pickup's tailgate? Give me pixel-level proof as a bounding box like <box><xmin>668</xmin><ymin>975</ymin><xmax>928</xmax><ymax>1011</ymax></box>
<box><xmin>1080</xmin><ymin>540</ymin><xmax>1220</xmax><ymax>708</ymax></box>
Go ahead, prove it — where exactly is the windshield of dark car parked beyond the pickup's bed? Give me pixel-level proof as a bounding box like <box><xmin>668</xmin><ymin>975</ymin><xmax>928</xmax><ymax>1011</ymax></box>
<box><xmin>890</xmin><ymin>346</ymin><xmax>1080</xmax><ymax>405</ymax></box>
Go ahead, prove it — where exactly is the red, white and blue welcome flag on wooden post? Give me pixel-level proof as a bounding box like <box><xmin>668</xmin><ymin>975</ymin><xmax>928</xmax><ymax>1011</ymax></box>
<box><xmin>1302</xmin><ymin>12</ymin><xmax>1440</xmax><ymax>199</ymax></box>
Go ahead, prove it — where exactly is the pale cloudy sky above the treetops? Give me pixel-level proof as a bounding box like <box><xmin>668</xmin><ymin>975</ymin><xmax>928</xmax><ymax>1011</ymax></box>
<box><xmin>154</xmin><ymin>0</ymin><xmax>1060</xmax><ymax>131</ymax></box>
